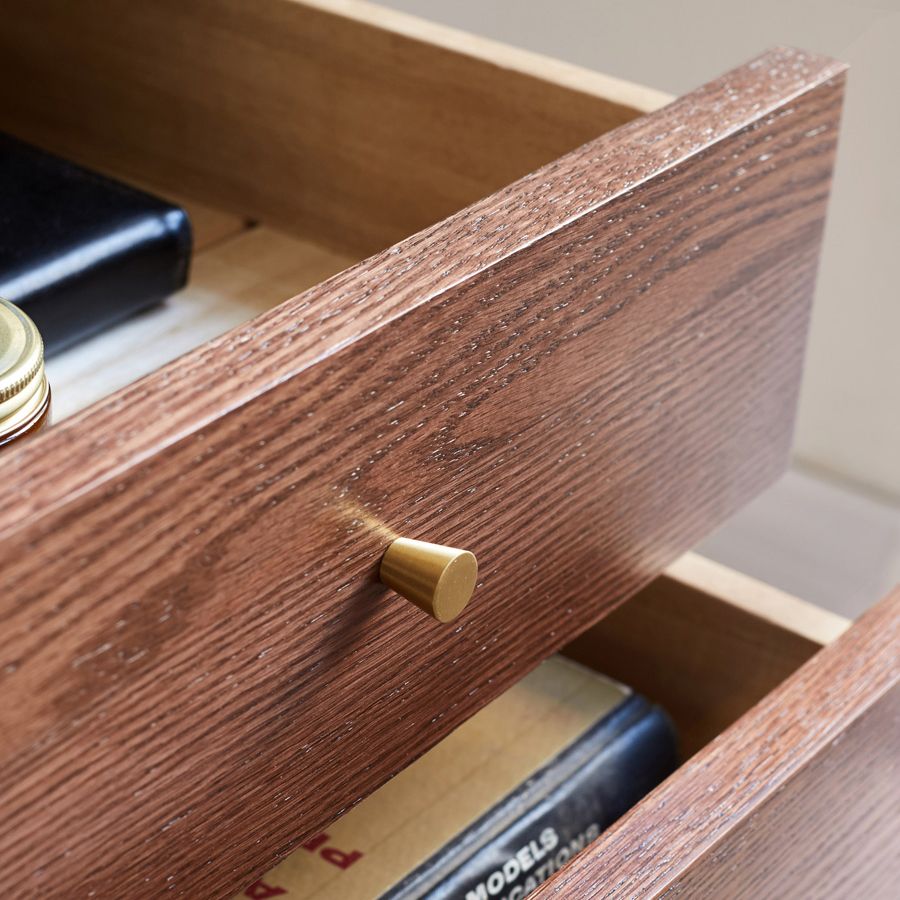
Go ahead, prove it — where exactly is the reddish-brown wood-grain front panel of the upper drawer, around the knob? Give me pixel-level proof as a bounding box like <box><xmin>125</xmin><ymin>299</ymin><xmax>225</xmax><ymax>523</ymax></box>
<box><xmin>0</xmin><ymin>50</ymin><xmax>843</xmax><ymax>897</ymax></box>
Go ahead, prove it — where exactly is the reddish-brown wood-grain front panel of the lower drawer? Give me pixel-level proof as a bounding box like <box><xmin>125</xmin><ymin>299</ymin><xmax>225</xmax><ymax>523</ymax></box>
<box><xmin>534</xmin><ymin>589</ymin><xmax>900</xmax><ymax>900</ymax></box>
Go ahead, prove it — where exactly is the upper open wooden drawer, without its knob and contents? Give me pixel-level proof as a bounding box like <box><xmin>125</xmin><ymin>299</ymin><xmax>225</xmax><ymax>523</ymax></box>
<box><xmin>0</xmin><ymin>0</ymin><xmax>856</xmax><ymax>896</ymax></box>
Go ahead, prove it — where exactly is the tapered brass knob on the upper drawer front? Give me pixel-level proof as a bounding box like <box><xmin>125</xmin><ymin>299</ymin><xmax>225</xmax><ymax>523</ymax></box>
<box><xmin>379</xmin><ymin>538</ymin><xmax>478</xmax><ymax>622</ymax></box>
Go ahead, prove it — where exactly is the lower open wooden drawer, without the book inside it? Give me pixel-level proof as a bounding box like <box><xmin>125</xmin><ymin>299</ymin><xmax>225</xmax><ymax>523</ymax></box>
<box><xmin>544</xmin><ymin>554</ymin><xmax>900</xmax><ymax>900</ymax></box>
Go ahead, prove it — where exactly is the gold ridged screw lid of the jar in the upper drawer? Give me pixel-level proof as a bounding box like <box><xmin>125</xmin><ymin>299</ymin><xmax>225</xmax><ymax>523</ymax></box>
<box><xmin>0</xmin><ymin>297</ymin><xmax>50</xmax><ymax>441</ymax></box>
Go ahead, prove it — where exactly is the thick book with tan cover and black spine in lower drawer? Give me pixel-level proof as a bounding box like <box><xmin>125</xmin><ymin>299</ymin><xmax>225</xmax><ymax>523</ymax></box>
<box><xmin>242</xmin><ymin>657</ymin><xmax>677</xmax><ymax>900</ymax></box>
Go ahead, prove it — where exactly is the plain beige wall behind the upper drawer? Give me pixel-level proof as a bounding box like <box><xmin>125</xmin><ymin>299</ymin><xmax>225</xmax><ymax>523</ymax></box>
<box><xmin>380</xmin><ymin>0</ymin><xmax>900</xmax><ymax>501</ymax></box>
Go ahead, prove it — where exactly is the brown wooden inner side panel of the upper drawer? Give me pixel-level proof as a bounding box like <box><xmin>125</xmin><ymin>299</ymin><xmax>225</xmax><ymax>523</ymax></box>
<box><xmin>0</xmin><ymin>0</ymin><xmax>668</xmax><ymax>255</ymax></box>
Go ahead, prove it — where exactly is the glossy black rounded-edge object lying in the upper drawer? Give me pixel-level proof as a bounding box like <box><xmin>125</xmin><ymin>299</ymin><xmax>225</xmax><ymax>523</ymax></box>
<box><xmin>0</xmin><ymin>134</ymin><xmax>191</xmax><ymax>355</ymax></box>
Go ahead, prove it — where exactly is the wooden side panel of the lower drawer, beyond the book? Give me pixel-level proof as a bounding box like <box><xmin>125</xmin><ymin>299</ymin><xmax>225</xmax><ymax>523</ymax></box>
<box><xmin>564</xmin><ymin>553</ymin><xmax>849</xmax><ymax>759</ymax></box>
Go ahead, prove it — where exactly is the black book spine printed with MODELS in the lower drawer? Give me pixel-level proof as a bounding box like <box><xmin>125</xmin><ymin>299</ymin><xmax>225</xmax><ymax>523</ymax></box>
<box><xmin>380</xmin><ymin>694</ymin><xmax>678</xmax><ymax>900</ymax></box>
